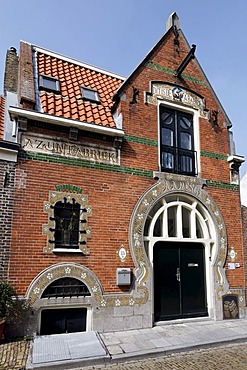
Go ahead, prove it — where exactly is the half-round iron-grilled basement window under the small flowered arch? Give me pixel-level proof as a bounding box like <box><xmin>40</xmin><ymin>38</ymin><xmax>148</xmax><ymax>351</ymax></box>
<box><xmin>41</xmin><ymin>278</ymin><xmax>91</xmax><ymax>298</ymax></box>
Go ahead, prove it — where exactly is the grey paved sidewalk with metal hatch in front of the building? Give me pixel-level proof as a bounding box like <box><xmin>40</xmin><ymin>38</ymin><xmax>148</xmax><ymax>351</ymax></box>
<box><xmin>10</xmin><ymin>318</ymin><xmax>247</xmax><ymax>370</ymax></box>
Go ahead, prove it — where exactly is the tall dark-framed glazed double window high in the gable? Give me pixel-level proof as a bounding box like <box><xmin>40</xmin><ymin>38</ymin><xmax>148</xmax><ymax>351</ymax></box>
<box><xmin>160</xmin><ymin>106</ymin><xmax>196</xmax><ymax>176</ymax></box>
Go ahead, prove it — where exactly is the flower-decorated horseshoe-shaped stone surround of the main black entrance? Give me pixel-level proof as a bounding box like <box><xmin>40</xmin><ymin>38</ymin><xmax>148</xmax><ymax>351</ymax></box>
<box><xmin>130</xmin><ymin>173</ymin><xmax>229</xmax><ymax>319</ymax></box>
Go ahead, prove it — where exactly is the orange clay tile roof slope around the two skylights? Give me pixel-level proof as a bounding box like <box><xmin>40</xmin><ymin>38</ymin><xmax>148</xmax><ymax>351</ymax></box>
<box><xmin>37</xmin><ymin>49</ymin><xmax>123</xmax><ymax>128</ymax></box>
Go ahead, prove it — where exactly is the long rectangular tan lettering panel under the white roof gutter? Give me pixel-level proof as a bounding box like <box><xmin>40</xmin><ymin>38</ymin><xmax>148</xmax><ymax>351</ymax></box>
<box><xmin>21</xmin><ymin>135</ymin><xmax>120</xmax><ymax>164</ymax></box>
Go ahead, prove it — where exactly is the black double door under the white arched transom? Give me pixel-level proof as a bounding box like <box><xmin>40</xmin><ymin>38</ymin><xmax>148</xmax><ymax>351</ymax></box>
<box><xmin>153</xmin><ymin>241</ymin><xmax>208</xmax><ymax>321</ymax></box>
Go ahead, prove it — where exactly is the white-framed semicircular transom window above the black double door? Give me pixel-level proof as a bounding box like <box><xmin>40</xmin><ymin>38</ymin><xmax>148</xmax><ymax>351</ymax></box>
<box><xmin>144</xmin><ymin>194</ymin><xmax>215</xmax><ymax>260</ymax></box>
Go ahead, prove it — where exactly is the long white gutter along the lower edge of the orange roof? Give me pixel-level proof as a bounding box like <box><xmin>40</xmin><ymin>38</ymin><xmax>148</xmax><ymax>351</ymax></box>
<box><xmin>9</xmin><ymin>106</ymin><xmax>125</xmax><ymax>137</ymax></box>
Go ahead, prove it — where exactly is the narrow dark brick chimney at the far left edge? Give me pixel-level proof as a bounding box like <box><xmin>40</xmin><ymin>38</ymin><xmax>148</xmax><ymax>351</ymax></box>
<box><xmin>3</xmin><ymin>47</ymin><xmax>19</xmax><ymax>94</ymax></box>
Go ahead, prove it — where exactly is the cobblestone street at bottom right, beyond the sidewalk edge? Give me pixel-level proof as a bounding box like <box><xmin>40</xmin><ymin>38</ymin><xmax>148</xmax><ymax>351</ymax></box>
<box><xmin>82</xmin><ymin>343</ymin><xmax>247</xmax><ymax>370</ymax></box>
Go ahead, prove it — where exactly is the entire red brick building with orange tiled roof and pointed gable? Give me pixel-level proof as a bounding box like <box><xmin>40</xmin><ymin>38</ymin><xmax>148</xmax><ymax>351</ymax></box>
<box><xmin>0</xmin><ymin>13</ymin><xmax>245</xmax><ymax>334</ymax></box>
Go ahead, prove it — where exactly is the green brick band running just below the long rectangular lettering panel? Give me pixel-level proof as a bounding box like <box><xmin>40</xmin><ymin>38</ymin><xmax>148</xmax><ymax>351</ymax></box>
<box><xmin>24</xmin><ymin>152</ymin><xmax>153</xmax><ymax>178</ymax></box>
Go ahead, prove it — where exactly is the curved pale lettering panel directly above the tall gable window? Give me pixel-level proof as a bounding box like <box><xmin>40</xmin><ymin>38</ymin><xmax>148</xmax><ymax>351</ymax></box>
<box><xmin>147</xmin><ymin>83</ymin><xmax>209</xmax><ymax>119</ymax></box>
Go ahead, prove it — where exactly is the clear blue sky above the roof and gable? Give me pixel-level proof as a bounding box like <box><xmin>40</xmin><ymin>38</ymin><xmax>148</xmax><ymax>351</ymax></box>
<box><xmin>0</xmin><ymin>0</ymin><xmax>247</xmax><ymax>175</ymax></box>
